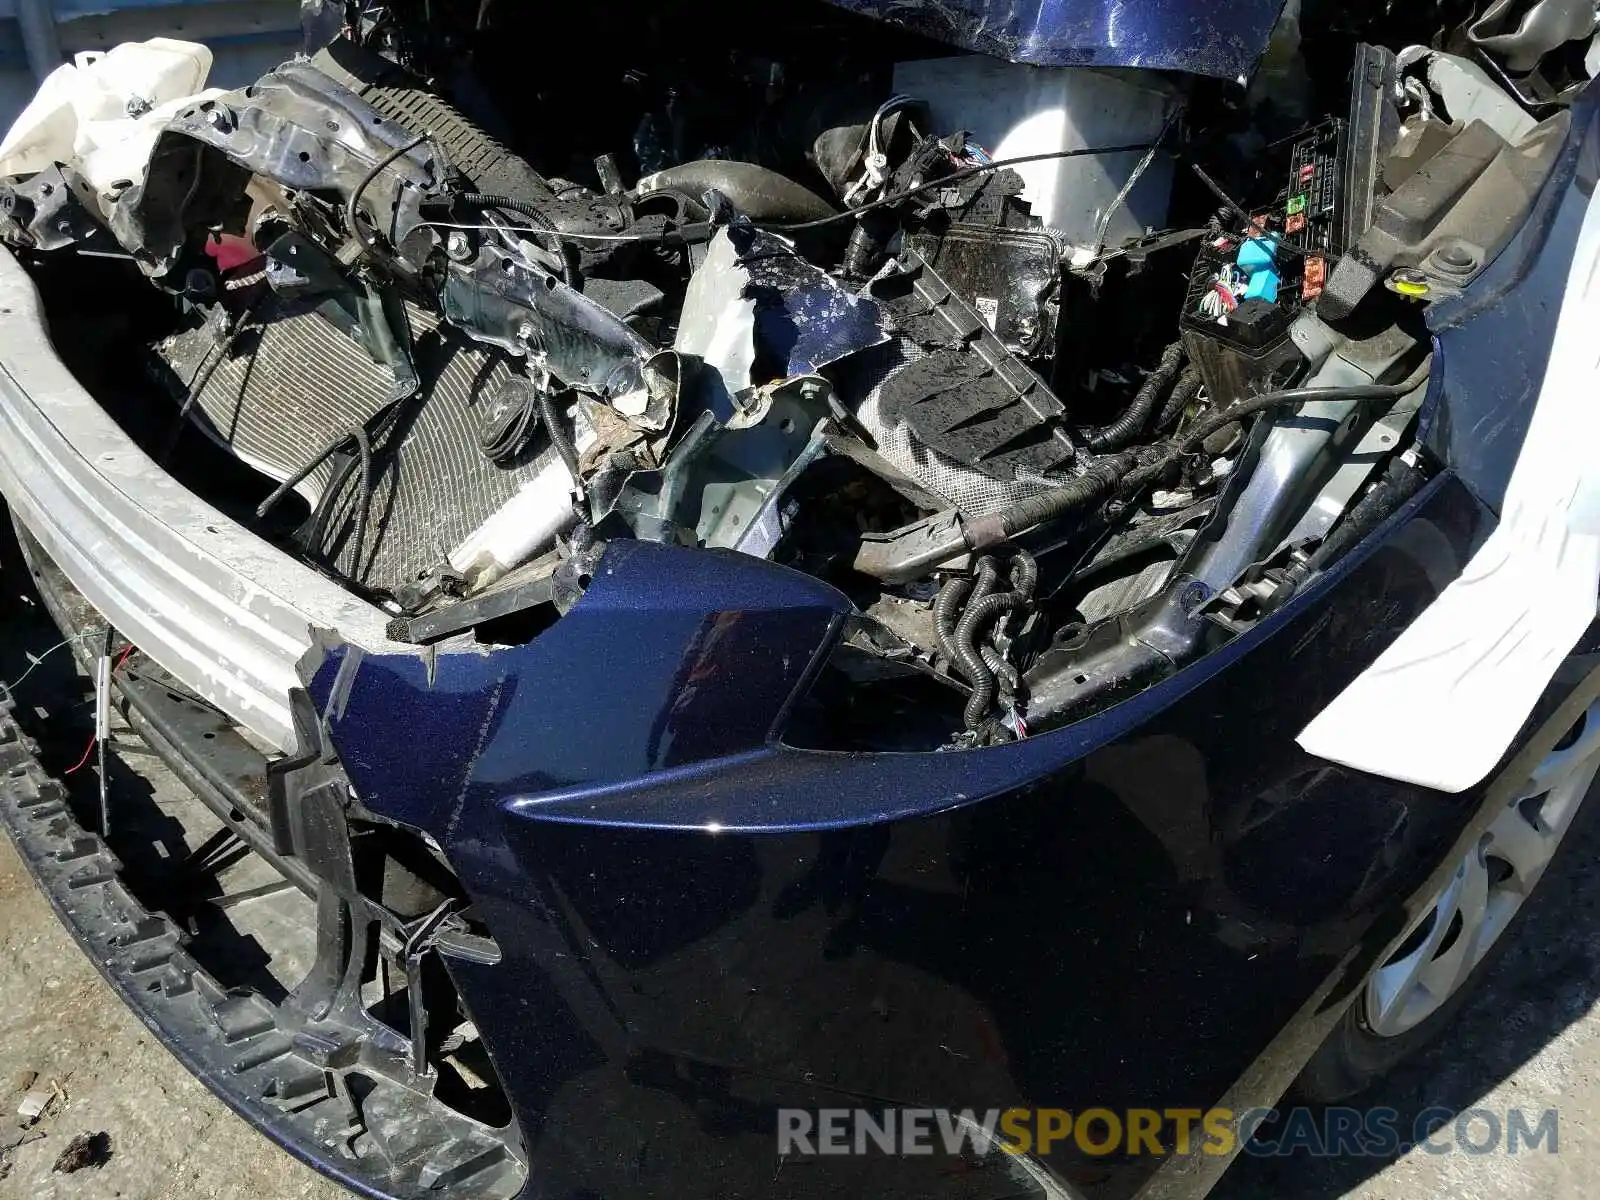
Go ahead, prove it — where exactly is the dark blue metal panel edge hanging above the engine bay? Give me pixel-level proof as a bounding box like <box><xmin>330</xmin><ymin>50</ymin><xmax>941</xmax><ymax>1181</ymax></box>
<box><xmin>832</xmin><ymin>0</ymin><xmax>1283</xmax><ymax>78</ymax></box>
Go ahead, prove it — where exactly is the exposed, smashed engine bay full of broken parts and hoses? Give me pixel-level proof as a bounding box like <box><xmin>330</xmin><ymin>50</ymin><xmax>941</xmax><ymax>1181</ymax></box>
<box><xmin>0</xmin><ymin>0</ymin><xmax>1597</xmax><ymax>750</ymax></box>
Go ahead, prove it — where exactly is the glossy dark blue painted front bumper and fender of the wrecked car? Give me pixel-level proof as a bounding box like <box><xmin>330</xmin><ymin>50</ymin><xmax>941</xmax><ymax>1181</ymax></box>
<box><xmin>312</xmin><ymin>84</ymin><xmax>1600</xmax><ymax>1200</ymax></box>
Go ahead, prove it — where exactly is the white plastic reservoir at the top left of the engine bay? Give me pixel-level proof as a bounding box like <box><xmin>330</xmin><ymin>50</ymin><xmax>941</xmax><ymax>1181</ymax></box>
<box><xmin>0</xmin><ymin>37</ymin><xmax>224</xmax><ymax>194</ymax></box>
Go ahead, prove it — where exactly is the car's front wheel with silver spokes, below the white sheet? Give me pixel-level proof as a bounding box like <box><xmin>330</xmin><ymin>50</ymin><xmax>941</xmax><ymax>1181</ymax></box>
<box><xmin>1291</xmin><ymin>704</ymin><xmax>1600</xmax><ymax>1104</ymax></box>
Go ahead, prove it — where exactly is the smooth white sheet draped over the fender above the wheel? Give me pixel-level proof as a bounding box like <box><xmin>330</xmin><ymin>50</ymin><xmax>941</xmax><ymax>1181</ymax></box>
<box><xmin>1299</xmin><ymin>183</ymin><xmax>1600</xmax><ymax>792</ymax></box>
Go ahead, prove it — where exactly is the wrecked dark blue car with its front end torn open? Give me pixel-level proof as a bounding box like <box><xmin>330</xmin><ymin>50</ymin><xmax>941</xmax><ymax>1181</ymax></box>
<box><xmin>0</xmin><ymin>0</ymin><xmax>1600</xmax><ymax>1200</ymax></box>
